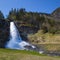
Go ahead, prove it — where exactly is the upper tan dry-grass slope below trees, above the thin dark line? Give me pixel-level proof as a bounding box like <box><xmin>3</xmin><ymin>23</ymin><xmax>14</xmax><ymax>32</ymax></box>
<box><xmin>28</xmin><ymin>31</ymin><xmax>60</xmax><ymax>44</ymax></box>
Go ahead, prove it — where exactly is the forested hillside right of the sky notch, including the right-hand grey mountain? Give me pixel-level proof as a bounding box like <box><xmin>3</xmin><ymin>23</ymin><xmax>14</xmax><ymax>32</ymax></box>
<box><xmin>7</xmin><ymin>8</ymin><xmax>60</xmax><ymax>34</ymax></box>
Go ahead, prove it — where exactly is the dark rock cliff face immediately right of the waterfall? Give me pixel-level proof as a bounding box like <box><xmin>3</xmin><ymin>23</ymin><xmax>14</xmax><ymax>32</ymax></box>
<box><xmin>15</xmin><ymin>22</ymin><xmax>38</xmax><ymax>41</ymax></box>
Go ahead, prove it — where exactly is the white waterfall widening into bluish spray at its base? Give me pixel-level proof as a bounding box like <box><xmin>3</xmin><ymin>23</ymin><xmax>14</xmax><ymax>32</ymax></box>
<box><xmin>6</xmin><ymin>22</ymin><xmax>35</xmax><ymax>50</ymax></box>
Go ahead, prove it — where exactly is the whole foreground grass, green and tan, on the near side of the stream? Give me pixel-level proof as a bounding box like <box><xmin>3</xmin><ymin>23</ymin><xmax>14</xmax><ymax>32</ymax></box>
<box><xmin>0</xmin><ymin>49</ymin><xmax>60</xmax><ymax>60</ymax></box>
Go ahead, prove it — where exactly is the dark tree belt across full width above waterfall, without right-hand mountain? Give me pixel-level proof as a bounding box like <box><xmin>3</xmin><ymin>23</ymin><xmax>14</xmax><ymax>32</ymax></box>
<box><xmin>0</xmin><ymin>8</ymin><xmax>60</xmax><ymax>34</ymax></box>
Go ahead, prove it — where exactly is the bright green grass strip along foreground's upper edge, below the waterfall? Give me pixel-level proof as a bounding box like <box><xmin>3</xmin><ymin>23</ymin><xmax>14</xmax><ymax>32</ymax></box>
<box><xmin>0</xmin><ymin>49</ymin><xmax>43</xmax><ymax>55</ymax></box>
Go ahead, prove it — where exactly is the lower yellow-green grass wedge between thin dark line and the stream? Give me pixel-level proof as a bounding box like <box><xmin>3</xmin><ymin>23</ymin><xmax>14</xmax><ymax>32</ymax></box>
<box><xmin>38</xmin><ymin>44</ymin><xmax>60</xmax><ymax>52</ymax></box>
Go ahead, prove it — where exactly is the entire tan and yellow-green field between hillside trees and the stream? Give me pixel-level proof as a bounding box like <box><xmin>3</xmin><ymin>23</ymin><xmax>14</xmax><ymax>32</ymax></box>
<box><xmin>28</xmin><ymin>31</ymin><xmax>60</xmax><ymax>51</ymax></box>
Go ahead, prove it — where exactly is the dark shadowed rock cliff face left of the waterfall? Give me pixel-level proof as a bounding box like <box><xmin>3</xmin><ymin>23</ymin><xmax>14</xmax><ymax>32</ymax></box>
<box><xmin>0</xmin><ymin>19</ymin><xmax>10</xmax><ymax>48</ymax></box>
